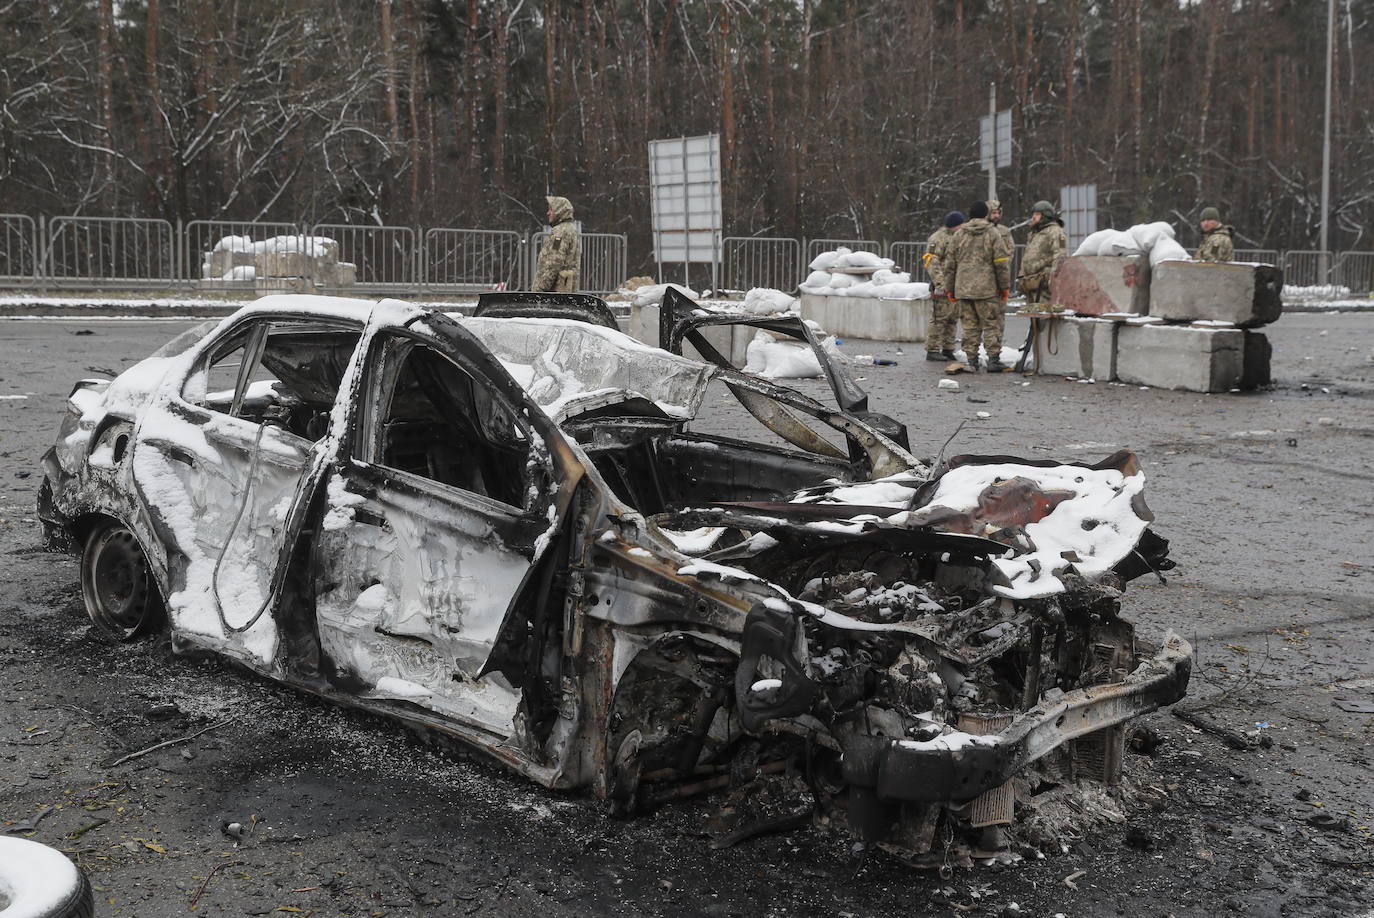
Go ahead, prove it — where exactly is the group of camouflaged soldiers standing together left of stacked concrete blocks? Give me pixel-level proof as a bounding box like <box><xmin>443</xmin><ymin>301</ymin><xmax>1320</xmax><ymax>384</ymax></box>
<box><xmin>925</xmin><ymin>199</ymin><xmax>1069</xmax><ymax>372</ymax></box>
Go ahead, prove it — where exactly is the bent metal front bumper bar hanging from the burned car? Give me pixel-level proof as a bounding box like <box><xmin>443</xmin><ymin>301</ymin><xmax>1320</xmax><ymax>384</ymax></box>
<box><xmin>842</xmin><ymin>632</ymin><xmax>1193</xmax><ymax>804</ymax></box>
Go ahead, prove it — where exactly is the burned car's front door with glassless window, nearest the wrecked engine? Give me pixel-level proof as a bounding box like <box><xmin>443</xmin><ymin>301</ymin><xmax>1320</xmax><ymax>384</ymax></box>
<box><xmin>315</xmin><ymin>322</ymin><xmax>561</xmax><ymax>739</ymax></box>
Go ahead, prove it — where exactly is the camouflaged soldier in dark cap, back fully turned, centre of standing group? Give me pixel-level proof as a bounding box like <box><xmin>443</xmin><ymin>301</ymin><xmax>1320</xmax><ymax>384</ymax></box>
<box><xmin>941</xmin><ymin>201</ymin><xmax>1011</xmax><ymax>372</ymax></box>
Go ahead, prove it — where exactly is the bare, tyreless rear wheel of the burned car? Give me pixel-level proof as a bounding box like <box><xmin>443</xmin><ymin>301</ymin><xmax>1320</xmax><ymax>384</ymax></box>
<box><xmin>79</xmin><ymin>519</ymin><xmax>162</xmax><ymax>643</ymax></box>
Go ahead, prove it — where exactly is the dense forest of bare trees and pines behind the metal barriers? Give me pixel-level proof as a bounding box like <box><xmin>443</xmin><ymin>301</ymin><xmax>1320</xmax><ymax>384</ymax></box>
<box><xmin>0</xmin><ymin>0</ymin><xmax>1374</xmax><ymax>268</ymax></box>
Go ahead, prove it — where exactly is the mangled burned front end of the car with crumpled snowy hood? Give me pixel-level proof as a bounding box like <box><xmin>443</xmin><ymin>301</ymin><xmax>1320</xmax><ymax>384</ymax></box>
<box><xmin>549</xmin><ymin>299</ymin><xmax>1191</xmax><ymax>863</ymax></box>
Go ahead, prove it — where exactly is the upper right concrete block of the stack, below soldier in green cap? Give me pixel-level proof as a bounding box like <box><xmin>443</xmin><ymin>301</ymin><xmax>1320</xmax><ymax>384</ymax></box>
<box><xmin>1150</xmin><ymin>261</ymin><xmax>1283</xmax><ymax>327</ymax></box>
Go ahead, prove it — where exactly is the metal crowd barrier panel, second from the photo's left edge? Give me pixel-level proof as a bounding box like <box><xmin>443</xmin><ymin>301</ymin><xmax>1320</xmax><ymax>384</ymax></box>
<box><xmin>43</xmin><ymin>216</ymin><xmax>176</xmax><ymax>287</ymax></box>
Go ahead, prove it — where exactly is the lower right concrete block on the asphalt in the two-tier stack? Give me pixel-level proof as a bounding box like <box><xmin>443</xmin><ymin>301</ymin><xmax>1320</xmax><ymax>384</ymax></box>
<box><xmin>1116</xmin><ymin>323</ymin><xmax>1245</xmax><ymax>392</ymax></box>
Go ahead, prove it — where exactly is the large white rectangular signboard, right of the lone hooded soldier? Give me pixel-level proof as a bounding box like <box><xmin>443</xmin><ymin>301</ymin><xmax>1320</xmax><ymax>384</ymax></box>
<box><xmin>649</xmin><ymin>133</ymin><xmax>723</xmax><ymax>264</ymax></box>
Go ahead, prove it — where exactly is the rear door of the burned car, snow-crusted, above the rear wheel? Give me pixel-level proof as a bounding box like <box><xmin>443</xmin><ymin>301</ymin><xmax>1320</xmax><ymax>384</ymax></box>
<box><xmin>135</xmin><ymin>316</ymin><xmax>361</xmax><ymax>668</ymax></box>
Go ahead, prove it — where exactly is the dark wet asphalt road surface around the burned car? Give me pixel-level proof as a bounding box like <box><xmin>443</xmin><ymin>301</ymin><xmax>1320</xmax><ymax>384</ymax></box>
<box><xmin>0</xmin><ymin>313</ymin><xmax>1374</xmax><ymax>918</ymax></box>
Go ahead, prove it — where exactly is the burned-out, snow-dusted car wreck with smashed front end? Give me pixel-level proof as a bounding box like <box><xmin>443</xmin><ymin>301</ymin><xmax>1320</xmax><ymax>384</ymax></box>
<box><xmin>38</xmin><ymin>294</ymin><xmax>1191</xmax><ymax>858</ymax></box>
